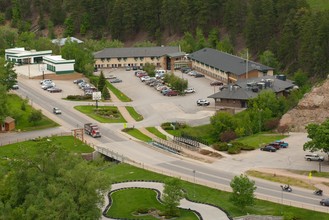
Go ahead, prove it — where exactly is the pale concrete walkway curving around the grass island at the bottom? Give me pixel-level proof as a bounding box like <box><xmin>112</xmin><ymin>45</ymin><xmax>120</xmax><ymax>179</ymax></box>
<box><xmin>102</xmin><ymin>181</ymin><xmax>229</xmax><ymax>220</ymax></box>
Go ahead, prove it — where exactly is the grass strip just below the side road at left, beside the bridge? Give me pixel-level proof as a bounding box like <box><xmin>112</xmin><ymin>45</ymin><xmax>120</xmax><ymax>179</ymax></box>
<box><xmin>0</xmin><ymin>136</ymin><xmax>94</xmax><ymax>158</ymax></box>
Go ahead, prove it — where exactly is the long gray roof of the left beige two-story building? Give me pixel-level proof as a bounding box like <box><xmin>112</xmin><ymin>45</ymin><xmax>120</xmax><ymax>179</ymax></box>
<box><xmin>94</xmin><ymin>46</ymin><xmax>180</xmax><ymax>59</ymax></box>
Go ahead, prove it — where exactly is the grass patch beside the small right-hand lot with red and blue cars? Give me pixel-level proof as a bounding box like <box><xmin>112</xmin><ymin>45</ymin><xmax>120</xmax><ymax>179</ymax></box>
<box><xmin>236</xmin><ymin>133</ymin><xmax>287</xmax><ymax>148</ymax></box>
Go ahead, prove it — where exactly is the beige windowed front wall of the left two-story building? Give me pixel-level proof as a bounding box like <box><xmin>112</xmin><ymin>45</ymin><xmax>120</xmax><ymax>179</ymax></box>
<box><xmin>95</xmin><ymin>57</ymin><xmax>167</xmax><ymax>69</ymax></box>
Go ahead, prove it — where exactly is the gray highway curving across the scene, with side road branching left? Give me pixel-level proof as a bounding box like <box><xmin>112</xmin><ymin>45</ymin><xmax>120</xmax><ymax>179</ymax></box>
<box><xmin>1</xmin><ymin>73</ymin><xmax>329</xmax><ymax>213</ymax></box>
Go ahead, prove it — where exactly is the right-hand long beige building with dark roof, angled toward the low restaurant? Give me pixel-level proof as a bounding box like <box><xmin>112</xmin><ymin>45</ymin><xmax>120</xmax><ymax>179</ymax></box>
<box><xmin>187</xmin><ymin>48</ymin><xmax>273</xmax><ymax>84</ymax></box>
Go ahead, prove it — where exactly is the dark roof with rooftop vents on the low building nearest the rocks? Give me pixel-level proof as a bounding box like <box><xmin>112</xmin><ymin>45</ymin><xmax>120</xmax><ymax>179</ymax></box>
<box><xmin>208</xmin><ymin>76</ymin><xmax>295</xmax><ymax>100</ymax></box>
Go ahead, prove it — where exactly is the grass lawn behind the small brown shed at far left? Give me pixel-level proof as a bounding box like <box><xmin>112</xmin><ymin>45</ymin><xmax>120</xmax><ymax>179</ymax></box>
<box><xmin>8</xmin><ymin>94</ymin><xmax>58</xmax><ymax>131</ymax></box>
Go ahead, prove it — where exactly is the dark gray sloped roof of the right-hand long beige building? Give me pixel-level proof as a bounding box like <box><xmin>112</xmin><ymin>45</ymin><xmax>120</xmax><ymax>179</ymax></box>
<box><xmin>187</xmin><ymin>48</ymin><xmax>273</xmax><ymax>75</ymax></box>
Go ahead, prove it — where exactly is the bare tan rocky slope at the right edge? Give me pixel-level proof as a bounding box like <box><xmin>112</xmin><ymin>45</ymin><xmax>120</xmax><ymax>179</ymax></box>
<box><xmin>280</xmin><ymin>79</ymin><xmax>329</xmax><ymax>132</ymax></box>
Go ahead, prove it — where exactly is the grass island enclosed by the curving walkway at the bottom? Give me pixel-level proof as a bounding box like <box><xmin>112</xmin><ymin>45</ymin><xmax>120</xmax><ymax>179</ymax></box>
<box><xmin>107</xmin><ymin>189</ymin><xmax>198</xmax><ymax>220</ymax></box>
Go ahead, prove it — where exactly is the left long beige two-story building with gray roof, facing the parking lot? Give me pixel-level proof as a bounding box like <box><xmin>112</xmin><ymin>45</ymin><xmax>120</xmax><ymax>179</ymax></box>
<box><xmin>94</xmin><ymin>46</ymin><xmax>185</xmax><ymax>70</ymax></box>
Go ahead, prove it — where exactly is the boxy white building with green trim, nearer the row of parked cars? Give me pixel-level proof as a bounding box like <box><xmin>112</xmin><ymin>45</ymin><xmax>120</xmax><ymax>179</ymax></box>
<box><xmin>43</xmin><ymin>55</ymin><xmax>75</xmax><ymax>74</ymax></box>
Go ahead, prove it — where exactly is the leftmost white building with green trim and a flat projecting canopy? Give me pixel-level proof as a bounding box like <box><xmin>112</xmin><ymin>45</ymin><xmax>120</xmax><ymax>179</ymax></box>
<box><xmin>5</xmin><ymin>47</ymin><xmax>52</xmax><ymax>65</ymax></box>
